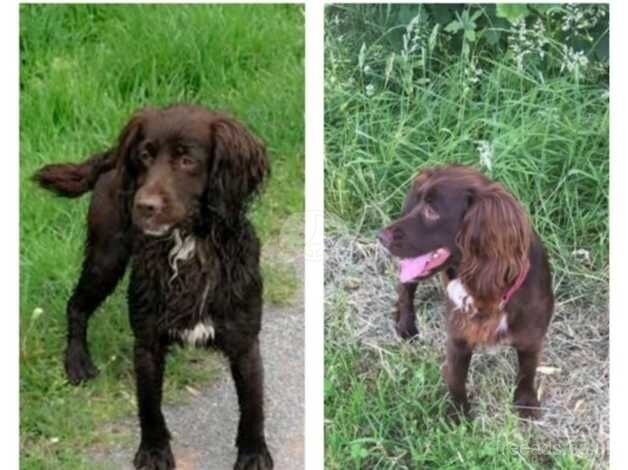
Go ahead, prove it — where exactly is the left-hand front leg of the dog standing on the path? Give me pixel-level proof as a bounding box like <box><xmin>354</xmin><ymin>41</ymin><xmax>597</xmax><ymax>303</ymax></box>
<box><xmin>133</xmin><ymin>339</ymin><xmax>175</xmax><ymax>470</ymax></box>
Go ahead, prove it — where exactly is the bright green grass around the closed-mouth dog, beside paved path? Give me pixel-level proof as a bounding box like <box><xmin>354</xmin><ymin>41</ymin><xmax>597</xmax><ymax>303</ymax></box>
<box><xmin>20</xmin><ymin>5</ymin><xmax>304</xmax><ymax>469</ymax></box>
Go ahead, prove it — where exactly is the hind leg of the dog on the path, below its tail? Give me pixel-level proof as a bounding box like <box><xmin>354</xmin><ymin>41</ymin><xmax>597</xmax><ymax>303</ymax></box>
<box><xmin>65</xmin><ymin>174</ymin><xmax>130</xmax><ymax>385</ymax></box>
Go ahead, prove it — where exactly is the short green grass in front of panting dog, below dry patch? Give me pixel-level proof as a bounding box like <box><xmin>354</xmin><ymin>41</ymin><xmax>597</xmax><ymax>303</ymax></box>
<box><xmin>325</xmin><ymin>345</ymin><xmax>595</xmax><ymax>470</ymax></box>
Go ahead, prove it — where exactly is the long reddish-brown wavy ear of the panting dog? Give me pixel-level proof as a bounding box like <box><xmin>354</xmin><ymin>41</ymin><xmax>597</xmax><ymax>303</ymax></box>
<box><xmin>456</xmin><ymin>183</ymin><xmax>532</xmax><ymax>312</ymax></box>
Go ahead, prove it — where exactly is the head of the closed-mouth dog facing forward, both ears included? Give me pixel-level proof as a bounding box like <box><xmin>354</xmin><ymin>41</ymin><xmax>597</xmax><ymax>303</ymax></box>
<box><xmin>112</xmin><ymin>105</ymin><xmax>270</xmax><ymax>236</ymax></box>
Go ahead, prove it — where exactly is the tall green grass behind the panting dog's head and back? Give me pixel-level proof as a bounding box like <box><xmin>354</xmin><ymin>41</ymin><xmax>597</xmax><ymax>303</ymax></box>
<box><xmin>325</xmin><ymin>3</ymin><xmax>609</xmax><ymax>269</ymax></box>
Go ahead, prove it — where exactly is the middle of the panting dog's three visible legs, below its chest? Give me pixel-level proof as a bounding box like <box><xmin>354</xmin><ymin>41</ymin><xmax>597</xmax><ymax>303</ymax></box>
<box><xmin>443</xmin><ymin>338</ymin><xmax>473</xmax><ymax>419</ymax></box>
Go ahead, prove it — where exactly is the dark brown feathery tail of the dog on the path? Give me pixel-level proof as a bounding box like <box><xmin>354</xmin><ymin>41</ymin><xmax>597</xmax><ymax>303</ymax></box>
<box><xmin>33</xmin><ymin>151</ymin><xmax>115</xmax><ymax>198</ymax></box>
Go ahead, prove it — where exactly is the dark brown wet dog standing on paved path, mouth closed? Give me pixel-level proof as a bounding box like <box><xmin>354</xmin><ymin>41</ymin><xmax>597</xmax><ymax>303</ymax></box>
<box><xmin>36</xmin><ymin>105</ymin><xmax>273</xmax><ymax>470</ymax></box>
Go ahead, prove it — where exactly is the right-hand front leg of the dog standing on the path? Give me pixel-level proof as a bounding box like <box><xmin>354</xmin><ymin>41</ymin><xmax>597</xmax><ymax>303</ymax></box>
<box><xmin>230</xmin><ymin>339</ymin><xmax>273</xmax><ymax>470</ymax></box>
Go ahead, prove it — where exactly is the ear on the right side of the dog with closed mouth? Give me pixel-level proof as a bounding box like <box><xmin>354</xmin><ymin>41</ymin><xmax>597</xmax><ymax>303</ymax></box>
<box><xmin>208</xmin><ymin>116</ymin><xmax>270</xmax><ymax>217</ymax></box>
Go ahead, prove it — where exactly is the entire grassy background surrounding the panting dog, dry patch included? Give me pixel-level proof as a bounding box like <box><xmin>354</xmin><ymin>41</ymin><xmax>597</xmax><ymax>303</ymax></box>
<box><xmin>325</xmin><ymin>4</ymin><xmax>609</xmax><ymax>469</ymax></box>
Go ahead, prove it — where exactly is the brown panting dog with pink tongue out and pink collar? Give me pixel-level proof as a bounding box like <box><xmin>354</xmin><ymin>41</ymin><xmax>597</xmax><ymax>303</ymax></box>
<box><xmin>379</xmin><ymin>166</ymin><xmax>554</xmax><ymax>417</ymax></box>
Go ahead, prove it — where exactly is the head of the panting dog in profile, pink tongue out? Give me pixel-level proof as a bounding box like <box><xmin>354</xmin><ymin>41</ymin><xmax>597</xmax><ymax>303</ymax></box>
<box><xmin>379</xmin><ymin>166</ymin><xmax>532</xmax><ymax>312</ymax></box>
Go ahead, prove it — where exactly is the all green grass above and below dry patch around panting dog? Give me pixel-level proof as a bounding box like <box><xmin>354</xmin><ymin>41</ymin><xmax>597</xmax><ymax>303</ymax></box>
<box><xmin>325</xmin><ymin>5</ymin><xmax>609</xmax><ymax>469</ymax></box>
